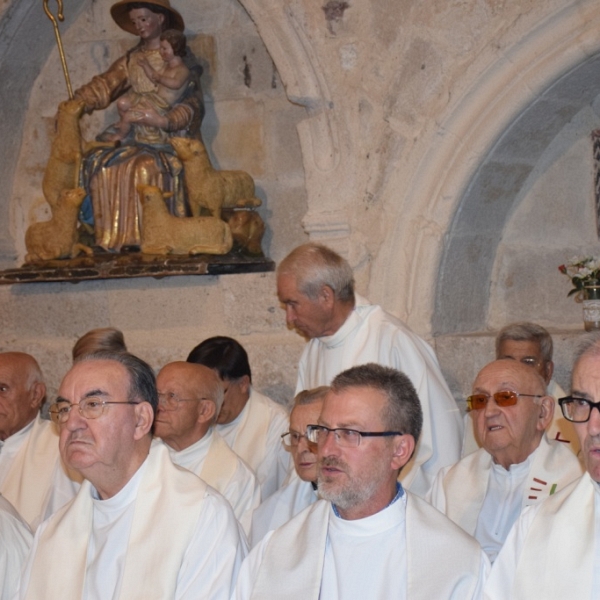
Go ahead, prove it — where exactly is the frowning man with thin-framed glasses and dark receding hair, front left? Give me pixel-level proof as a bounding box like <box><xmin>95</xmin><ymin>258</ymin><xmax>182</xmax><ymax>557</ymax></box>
<box><xmin>17</xmin><ymin>352</ymin><xmax>244</xmax><ymax>600</ymax></box>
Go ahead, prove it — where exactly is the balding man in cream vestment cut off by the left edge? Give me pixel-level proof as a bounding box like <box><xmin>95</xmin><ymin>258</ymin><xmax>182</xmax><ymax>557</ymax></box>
<box><xmin>0</xmin><ymin>352</ymin><xmax>81</xmax><ymax>531</ymax></box>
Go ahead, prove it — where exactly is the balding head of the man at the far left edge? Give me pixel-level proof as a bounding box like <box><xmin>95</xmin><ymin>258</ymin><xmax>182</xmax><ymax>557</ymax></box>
<box><xmin>0</xmin><ymin>352</ymin><xmax>46</xmax><ymax>441</ymax></box>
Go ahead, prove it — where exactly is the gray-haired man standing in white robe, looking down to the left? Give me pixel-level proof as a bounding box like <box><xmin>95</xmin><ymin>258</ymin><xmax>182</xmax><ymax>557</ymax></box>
<box><xmin>277</xmin><ymin>243</ymin><xmax>463</xmax><ymax>496</ymax></box>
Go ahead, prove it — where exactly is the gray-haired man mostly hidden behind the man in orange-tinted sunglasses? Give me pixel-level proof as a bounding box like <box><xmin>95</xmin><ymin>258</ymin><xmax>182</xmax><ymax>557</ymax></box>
<box><xmin>462</xmin><ymin>321</ymin><xmax>579</xmax><ymax>456</ymax></box>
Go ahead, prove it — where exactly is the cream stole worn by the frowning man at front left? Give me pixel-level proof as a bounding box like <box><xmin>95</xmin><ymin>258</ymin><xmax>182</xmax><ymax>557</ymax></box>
<box><xmin>24</xmin><ymin>444</ymin><xmax>206</xmax><ymax>600</ymax></box>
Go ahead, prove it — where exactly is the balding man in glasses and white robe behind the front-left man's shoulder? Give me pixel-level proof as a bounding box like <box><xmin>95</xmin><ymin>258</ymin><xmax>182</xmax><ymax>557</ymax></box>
<box><xmin>154</xmin><ymin>362</ymin><xmax>260</xmax><ymax>532</ymax></box>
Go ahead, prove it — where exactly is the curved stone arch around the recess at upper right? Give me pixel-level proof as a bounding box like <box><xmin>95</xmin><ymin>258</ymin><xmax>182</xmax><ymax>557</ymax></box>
<box><xmin>376</xmin><ymin>2</ymin><xmax>600</xmax><ymax>335</ymax></box>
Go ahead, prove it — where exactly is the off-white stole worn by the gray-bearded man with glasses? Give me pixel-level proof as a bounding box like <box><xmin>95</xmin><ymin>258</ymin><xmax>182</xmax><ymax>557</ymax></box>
<box><xmin>250</xmin><ymin>492</ymin><xmax>482</xmax><ymax>600</ymax></box>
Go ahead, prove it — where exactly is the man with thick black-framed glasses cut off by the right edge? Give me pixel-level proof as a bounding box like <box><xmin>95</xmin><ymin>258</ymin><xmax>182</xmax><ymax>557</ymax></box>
<box><xmin>486</xmin><ymin>334</ymin><xmax>600</xmax><ymax>599</ymax></box>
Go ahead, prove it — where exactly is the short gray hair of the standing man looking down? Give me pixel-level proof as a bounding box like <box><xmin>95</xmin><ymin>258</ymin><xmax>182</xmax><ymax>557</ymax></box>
<box><xmin>277</xmin><ymin>243</ymin><xmax>354</xmax><ymax>303</ymax></box>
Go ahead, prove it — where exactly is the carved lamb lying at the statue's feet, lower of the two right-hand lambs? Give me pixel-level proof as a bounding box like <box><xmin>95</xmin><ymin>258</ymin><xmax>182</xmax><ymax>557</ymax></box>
<box><xmin>138</xmin><ymin>185</ymin><xmax>233</xmax><ymax>254</ymax></box>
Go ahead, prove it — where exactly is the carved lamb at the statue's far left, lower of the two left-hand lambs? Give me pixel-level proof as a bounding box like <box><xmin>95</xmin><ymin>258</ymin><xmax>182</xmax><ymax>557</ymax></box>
<box><xmin>25</xmin><ymin>188</ymin><xmax>92</xmax><ymax>263</ymax></box>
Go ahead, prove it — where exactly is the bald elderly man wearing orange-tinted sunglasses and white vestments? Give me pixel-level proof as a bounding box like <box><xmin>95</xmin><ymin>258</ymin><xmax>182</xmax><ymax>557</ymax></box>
<box><xmin>429</xmin><ymin>359</ymin><xmax>582</xmax><ymax>562</ymax></box>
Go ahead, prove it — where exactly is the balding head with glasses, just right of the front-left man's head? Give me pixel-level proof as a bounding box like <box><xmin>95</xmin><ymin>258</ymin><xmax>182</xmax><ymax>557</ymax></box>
<box><xmin>154</xmin><ymin>362</ymin><xmax>223</xmax><ymax>451</ymax></box>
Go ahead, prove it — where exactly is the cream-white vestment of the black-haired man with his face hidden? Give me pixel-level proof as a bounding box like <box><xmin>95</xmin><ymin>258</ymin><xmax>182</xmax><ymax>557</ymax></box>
<box><xmin>215</xmin><ymin>389</ymin><xmax>290</xmax><ymax>500</ymax></box>
